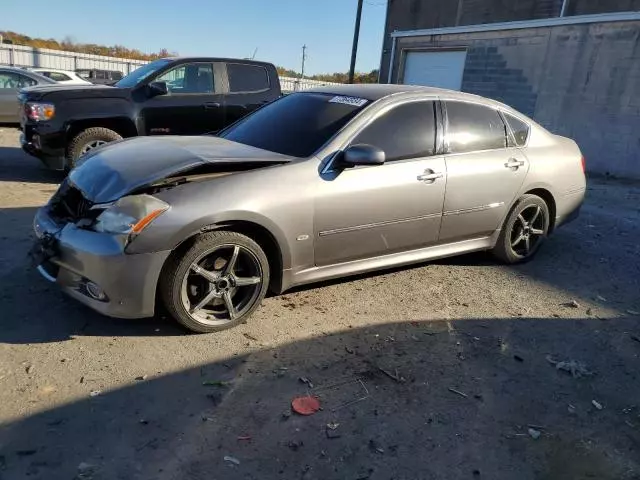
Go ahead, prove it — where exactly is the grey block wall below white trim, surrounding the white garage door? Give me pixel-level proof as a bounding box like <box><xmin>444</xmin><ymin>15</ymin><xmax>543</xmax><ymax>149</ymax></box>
<box><xmin>393</xmin><ymin>22</ymin><xmax>640</xmax><ymax>178</ymax></box>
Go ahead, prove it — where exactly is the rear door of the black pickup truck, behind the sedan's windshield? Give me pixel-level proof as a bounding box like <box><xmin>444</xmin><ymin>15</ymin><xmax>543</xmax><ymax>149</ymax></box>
<box><xmin>225</xmin><ymin>62</ymin><xmax>273</xmax><ymax>124</ymax></box>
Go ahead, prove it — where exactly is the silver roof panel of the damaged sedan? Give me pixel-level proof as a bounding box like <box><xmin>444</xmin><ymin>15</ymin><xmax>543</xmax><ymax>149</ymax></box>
<box><xmin>303</xmin><ymin>83</ymin><xmax>508</xmax><ymax>108</ymax></box>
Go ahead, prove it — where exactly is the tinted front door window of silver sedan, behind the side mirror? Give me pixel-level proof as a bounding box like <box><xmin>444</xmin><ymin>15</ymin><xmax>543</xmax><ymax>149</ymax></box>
<box><xmin>351</xmin><ymin>102</ymin><xmax>436</xmax><ymax>161</ymax></box>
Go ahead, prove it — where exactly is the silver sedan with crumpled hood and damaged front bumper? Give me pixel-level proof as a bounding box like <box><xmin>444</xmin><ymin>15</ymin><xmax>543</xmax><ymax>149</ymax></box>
<box><xmin>33</xmin><ymin>85</ymin><xmax>585</xmax><ymax>332</ymax></box>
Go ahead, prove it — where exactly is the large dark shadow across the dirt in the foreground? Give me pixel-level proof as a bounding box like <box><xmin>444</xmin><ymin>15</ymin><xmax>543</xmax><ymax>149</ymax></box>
<box><xmin>0</xmin><ymin>318</ymin><xmax>640</xmax><ymax>480</ymax></box>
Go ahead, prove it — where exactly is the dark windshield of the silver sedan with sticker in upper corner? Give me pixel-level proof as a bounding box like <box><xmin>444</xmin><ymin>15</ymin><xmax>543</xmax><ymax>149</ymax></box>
<box><xmin>220</xmin><ymin>93</ymin><xmax>369</xmax><ymax>158</ymax></box>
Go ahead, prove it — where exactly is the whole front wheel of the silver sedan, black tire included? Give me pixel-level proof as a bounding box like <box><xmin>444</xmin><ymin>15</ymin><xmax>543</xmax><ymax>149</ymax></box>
<box><xmin>160</xmin><ymin>230</ymin><xmax>269</xmax><ymax>333</ymax></box>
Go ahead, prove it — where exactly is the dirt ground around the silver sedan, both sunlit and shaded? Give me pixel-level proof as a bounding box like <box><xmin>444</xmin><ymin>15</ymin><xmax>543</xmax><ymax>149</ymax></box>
<box><xmin>0</xmin><ymin>126</ymin><xmax>640</xmax><ymax>480</ymax></box>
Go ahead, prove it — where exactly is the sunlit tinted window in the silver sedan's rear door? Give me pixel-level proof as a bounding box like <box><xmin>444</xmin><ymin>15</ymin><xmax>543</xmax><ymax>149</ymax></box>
<box><xmin>446</xmin><ymin>102</ymin><xmax>507</xmax><ymax>153</ymax></box>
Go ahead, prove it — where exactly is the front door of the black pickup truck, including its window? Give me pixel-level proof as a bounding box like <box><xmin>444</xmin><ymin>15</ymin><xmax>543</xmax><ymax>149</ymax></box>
<box><xmin>141</xmin><ymin>62</ymin><xmax>225</xmax><ymax>135</ymax></box>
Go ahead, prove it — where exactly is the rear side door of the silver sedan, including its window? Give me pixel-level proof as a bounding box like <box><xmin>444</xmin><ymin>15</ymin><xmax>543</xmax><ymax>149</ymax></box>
<box><xmin>440</xmin><ymin>101</ymin><xmax>529</xmax><ymax>243</ymax></box>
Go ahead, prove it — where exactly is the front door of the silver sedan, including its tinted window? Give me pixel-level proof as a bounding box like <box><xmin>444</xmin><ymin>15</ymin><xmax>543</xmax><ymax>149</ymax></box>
<box><xmin>314</xmin><ymin>101</ymin><xmax>446</xmax><ymax>266</ymax></box>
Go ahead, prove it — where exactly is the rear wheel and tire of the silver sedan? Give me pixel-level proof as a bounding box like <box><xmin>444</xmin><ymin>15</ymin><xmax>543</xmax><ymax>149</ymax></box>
<box><xmin>491</xmin><ymin>194</ymin><xmax>550</xmax><ymax>264</ymax></box>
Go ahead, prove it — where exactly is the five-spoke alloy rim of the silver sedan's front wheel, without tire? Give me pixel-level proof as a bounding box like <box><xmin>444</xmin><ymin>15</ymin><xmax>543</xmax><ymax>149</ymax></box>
<box><xmin>181</xmin><ymin>244</ymin><xmax>263</xmax><ymax>326</ymax></box>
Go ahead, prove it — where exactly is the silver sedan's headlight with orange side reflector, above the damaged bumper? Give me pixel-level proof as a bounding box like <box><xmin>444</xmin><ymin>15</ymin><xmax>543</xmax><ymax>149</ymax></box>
<box><xmin>92</xmin><ymin>195</ymin><xmax>169</xmax><ymax>235</ymax></box>
